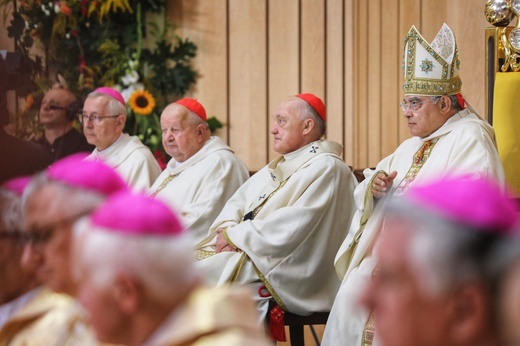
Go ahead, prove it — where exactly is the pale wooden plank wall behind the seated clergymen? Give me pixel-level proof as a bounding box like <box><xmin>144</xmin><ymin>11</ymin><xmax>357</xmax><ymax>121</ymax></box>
<box><xmin>0</xmin><ymin>0</ymin><xmax>496</xmax><ymax>170</ymax></box>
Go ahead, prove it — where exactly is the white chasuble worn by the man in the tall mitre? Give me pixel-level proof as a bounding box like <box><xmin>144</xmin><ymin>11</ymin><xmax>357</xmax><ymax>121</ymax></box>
<box><xmin>322</xmin><ymin>109</ymin><xmax>505</xmax><ymax>346</ymax></box>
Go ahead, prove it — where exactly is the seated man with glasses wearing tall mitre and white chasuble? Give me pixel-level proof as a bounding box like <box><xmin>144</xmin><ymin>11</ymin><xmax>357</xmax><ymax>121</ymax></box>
<box><xmin>323</xmin><ymin>24</ymin><xmax>505</xmax><ymax>345</ymax></box>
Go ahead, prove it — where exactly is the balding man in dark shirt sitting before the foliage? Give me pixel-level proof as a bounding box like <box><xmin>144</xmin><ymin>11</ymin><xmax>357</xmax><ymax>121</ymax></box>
<box><xmin>37</xmin><ymin>84</ymin><xmax>94</xmax><ymax>164</ymax></box>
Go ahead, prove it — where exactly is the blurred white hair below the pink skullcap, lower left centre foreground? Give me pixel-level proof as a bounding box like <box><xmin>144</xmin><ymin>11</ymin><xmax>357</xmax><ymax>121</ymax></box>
<box><xmin>74</xmin><ymin>217</ymin><xmax>200</xmax><ymax>302</ymax></box>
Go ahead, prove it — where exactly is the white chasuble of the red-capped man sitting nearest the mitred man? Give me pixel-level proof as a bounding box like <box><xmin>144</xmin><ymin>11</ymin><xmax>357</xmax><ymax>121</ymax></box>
<box><xmin>198</xmin><ymin>141</ymin><xmax>357</xmax><ymax>315</ymax></box>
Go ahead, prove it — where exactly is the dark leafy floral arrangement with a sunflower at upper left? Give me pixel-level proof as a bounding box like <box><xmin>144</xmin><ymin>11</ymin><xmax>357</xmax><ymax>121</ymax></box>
<box><xmin>0</xmin><ymin>0</ymin><xmax>222</xmax><ymax>159</ymax></box>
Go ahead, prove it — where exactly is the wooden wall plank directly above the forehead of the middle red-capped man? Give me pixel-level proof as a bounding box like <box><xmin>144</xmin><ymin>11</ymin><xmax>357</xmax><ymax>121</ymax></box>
<box><xmin>267</xmin><ymin>0</ymin><xmax>300</xmax><ymax>161</ymax></box>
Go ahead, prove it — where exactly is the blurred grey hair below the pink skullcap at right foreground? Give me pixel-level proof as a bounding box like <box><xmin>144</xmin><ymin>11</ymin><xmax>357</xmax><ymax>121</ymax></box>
<box><xmin>385</xmin><ymin>199</ymin><xmax>498</xmax><ymax>296</ymax></box>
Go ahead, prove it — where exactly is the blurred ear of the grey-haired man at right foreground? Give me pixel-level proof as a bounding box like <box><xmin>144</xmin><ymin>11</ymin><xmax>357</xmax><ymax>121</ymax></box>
<box><xmin>451</xmin><ymin>283</ymin><xmax>491</xmax><ymax>344</ymax></box>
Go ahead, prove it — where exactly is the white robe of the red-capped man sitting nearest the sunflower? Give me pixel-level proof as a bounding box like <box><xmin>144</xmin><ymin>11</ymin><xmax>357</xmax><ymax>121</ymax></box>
<box><xmin>149</xmin><ymin>137</ymin><xmax>249</xmax><ymax>245</ymax></box>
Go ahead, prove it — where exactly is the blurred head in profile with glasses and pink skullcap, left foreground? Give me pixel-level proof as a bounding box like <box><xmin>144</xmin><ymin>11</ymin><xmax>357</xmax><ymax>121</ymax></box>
<box><xmin>22</xmin><ymin>154</ymin><xmax>128</xmax><ymax>295</ymax></box>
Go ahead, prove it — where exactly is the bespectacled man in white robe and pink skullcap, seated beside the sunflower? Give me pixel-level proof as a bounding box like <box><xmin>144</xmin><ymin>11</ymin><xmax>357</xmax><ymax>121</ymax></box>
<box><xmin>80</xmin><ymin>87</ymin><xmax>162</xmax><ymax>190</ymax></box>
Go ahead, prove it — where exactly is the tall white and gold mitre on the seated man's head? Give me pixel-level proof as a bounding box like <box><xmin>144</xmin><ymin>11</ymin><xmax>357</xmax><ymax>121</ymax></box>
<box><xmin>403</xmin><ymin>23</ymin><xmax>462</xmax><ymax>95</ymax></box>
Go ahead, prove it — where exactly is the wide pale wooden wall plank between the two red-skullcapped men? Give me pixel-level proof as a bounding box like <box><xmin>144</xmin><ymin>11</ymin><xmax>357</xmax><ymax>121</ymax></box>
<box><xmin>228</xmin><ymin>0</ymin><xmax>270</xmax><ymax>171</ymax></box>
